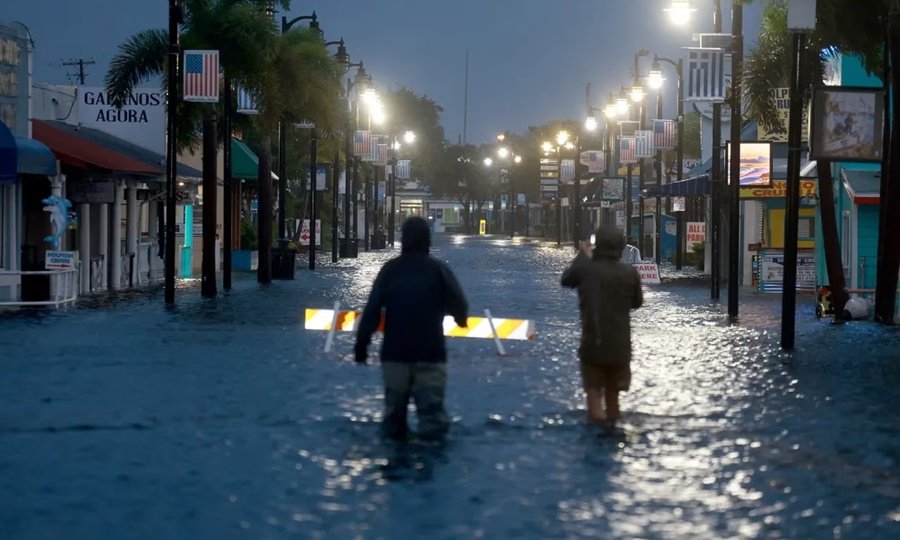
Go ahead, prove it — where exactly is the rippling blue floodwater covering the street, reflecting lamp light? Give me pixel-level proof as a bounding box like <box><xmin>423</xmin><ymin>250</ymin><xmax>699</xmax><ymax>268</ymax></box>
<box><xmin>0</xmin><ymin>236</ymin><xmax>900</xmax><ymax>540</ymax></box>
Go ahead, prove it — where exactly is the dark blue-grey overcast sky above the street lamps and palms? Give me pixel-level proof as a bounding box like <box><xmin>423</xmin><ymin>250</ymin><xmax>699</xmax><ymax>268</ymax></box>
<box><xmin>7</xmin><ymin>0</ymin><xmax>764</xmax><ymax>144</ymax></box>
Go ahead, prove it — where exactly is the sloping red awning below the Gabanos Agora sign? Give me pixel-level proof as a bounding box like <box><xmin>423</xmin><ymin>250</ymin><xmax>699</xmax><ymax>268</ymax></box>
<box><xmin>32</xmin><ymin>120</ymin><xmax>165</xmax><ymax>176</ymax></box>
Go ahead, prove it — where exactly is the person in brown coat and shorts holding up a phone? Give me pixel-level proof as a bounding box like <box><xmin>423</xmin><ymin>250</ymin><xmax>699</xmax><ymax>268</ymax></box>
<box><xmin>561</xmin><ymin>227</ymin><xmax>644</xmax><ymax>428</ymax></box>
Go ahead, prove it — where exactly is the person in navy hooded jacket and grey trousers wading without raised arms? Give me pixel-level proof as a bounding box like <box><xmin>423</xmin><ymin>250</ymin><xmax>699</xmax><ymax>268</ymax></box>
<box><xmin>354</xmin><ymin>217</ymin><xmax>469</xmax><ymax>439</ymax></box>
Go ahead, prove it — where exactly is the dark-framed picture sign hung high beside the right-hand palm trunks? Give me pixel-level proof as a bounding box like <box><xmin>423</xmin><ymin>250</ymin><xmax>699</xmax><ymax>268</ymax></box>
<box><xmin>810</xmin><ymin>86</ymin><xmax>884</xmax><ymax>162</ymax></box>
